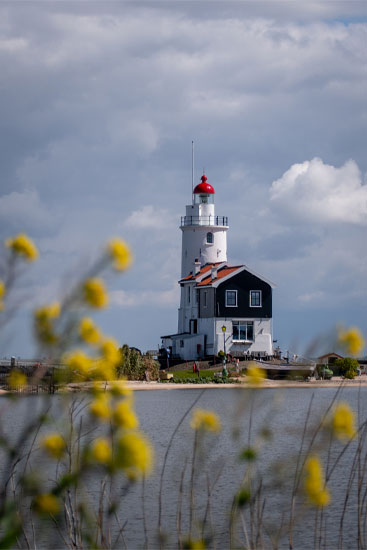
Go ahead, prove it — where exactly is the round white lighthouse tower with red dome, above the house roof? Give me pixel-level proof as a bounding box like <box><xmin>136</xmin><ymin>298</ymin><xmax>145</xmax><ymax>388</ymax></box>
<box><xmin>180</xmin><ymin>174</ymin><xmax>228</xmax><ymax>277</ymax></box>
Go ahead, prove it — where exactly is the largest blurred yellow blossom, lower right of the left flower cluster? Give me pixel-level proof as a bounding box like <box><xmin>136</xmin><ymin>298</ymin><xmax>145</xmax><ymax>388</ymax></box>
<box><xmin>116</xmin><ymin>432</ymin><xmax>153</xmax><ymax>480</ymax></box>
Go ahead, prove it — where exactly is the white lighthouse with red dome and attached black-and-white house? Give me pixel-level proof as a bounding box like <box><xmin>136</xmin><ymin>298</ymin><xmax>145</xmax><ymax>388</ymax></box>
<box><xmin>161</xmin><ymin>170</ymin><xmax>275</xmax><ymax>362</ymax></box>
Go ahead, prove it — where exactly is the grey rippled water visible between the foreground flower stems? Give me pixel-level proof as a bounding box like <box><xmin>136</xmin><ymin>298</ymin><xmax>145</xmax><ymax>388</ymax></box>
<box><xmin>0</xmin><ymin>388</ymin><xmax>367</xmax><ymax>550</ymax></box>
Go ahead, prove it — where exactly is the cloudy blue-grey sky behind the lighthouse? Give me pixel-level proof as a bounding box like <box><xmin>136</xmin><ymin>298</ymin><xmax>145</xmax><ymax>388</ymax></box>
<box><xmin>0</xmin><ymin>0</ymin><xmax>367</xmax><ymax>357</ymax></box>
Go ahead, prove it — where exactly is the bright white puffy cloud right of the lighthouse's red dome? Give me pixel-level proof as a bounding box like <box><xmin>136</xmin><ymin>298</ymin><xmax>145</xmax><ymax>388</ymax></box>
<box><xmin>270</xmin><ymin>158</ymin><xmax>367</xmax><ymax>225</ymax></box>
